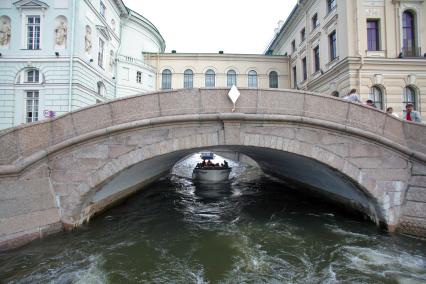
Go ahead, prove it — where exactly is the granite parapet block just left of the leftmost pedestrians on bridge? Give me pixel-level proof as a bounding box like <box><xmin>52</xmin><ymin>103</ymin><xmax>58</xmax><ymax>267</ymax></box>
<box><xmin>304</xmin><ymin>94</ymin><xmax>349</xmax><ymax>123</ymax></box>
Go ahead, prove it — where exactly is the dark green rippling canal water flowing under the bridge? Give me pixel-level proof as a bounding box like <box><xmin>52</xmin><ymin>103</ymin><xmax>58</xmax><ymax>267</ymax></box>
<box><xmin>0</xmin><ymin>157</ymin><xmax>426</xmax><ymax>283</ymax></box>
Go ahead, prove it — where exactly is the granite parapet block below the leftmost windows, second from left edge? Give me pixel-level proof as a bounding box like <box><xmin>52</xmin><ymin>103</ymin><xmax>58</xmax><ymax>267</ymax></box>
<box><xmin>18</xmin><ymin>123</ymin><xmax>51</xmax><ymax>156</ymax></box>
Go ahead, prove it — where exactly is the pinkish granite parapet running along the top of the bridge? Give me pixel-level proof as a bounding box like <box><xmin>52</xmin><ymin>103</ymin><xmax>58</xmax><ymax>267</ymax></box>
<box><xmin>0</xmin><ymin>88</ymin><xmax>426</xmax><ymax>170</ymax></box>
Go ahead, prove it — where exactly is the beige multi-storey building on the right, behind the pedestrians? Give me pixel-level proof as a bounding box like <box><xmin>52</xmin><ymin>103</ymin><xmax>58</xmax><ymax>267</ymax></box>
<box><xmin>266</xmin><ymin>0</ymin><xmax>426</xmax><ymax>118</ymax></box>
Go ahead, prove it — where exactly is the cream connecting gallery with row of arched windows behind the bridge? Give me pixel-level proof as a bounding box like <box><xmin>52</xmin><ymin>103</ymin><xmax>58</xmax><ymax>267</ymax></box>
<box><xmin>145</xmin><ymin>52</ymin><xmax>290</xmax><ymax>90</ymax></box>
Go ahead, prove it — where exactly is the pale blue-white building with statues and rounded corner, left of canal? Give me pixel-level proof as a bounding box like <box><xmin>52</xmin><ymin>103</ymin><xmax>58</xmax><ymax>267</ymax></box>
<box><xmin>0</xmin><ymin>0</ymin><xmax>165</xmax><ymax>129</ymax></box>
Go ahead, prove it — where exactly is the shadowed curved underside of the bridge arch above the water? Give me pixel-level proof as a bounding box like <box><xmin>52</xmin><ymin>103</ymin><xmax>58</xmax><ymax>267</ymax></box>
<box><xmin>90</xmin><ymin>146</ymin><xmax>385</xmax><ymax>229</ymax></box>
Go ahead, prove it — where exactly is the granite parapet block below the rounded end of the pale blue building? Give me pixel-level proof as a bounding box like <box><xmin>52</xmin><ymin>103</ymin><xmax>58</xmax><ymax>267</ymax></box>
<box><xmin>111</xmin><ymin>93</ymin><xmax>160</xmax><ymax>125</ymax></box>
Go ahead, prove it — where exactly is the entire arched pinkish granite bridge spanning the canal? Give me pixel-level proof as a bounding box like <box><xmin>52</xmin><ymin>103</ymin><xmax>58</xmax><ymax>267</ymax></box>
<box><xmin>0</xmin><ymin>89</ymin><xmax>426</xmax><ymax>249</ymax></box>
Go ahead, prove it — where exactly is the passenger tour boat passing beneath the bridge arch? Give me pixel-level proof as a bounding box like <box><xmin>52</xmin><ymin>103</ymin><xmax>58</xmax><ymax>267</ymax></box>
<box><xmin>192</xmin><ymin>152</ymin><xmax>232</xmax><ymax>183</ymax></box>
